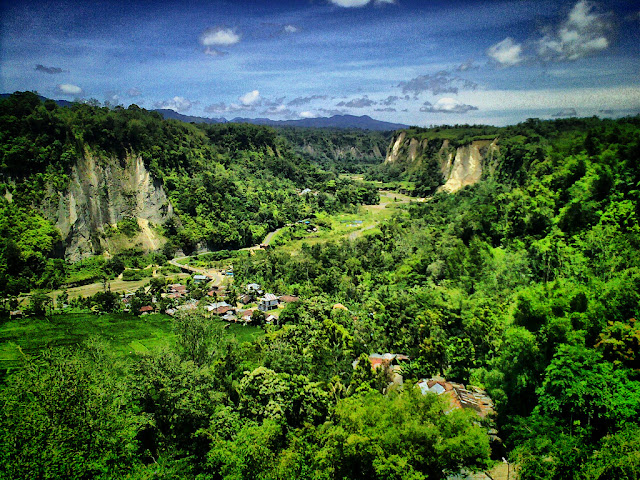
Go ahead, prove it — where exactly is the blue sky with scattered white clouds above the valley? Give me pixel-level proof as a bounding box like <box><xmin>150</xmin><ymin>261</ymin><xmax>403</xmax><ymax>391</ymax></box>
<box><xmin>0</xmin><ymin>0</ymin><xmax>640</xmax><ymax>126</ymax></box>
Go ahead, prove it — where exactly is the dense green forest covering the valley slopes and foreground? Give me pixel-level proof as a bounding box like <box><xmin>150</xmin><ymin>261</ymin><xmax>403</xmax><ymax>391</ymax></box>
<box><xmin>0</xmin><ymin>93</ymin><xmax>640</xmax><ymax>480</ymax></box>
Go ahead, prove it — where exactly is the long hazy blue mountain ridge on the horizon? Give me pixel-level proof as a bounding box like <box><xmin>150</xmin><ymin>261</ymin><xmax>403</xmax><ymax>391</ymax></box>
<box><xmin>155</xmin><ymin>109</ymin><xmax>409</xmax><ymax>132</ymax></box>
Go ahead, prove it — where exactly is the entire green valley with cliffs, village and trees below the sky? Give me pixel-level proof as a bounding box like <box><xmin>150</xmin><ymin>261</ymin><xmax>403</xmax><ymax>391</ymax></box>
<box><xmin>0</xmin><ymin>92</ymin><xmax>640</xmax><ymax>480</ymax></box>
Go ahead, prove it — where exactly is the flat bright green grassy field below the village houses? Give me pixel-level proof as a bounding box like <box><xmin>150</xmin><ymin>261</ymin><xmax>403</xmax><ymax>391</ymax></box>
<box><xmin>0</xmin><ymin>313</ymin><xmax>263</xmax><ymax>371</ymax></box>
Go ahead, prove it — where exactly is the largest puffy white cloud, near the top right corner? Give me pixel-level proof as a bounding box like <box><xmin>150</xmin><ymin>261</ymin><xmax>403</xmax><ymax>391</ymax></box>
<box><xmin>537</xmin><ymin>0</ymin><xmax>612</xmax><ymax>60</ymax></box>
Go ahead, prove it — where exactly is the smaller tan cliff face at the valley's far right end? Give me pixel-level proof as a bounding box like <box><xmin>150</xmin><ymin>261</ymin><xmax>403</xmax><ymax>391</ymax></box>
<box><xmin>385</xmin><ymin>132</ymin><xmax>498</xmax><ymax>193</ymax></box>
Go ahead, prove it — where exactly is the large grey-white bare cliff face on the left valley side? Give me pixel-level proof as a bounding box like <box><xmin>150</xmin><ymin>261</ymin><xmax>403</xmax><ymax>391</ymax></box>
<box><xmin>39</xmin><ymin>151</ymin><xmax>173</xmax><ymax>261</ymax></box>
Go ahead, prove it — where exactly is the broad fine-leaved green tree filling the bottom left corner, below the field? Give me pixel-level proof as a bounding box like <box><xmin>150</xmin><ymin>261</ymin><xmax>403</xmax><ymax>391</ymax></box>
<box><xmin>0</xmin><ymin>350</ymin><xmax>145</xmax><ymax>478</ymax></box>
